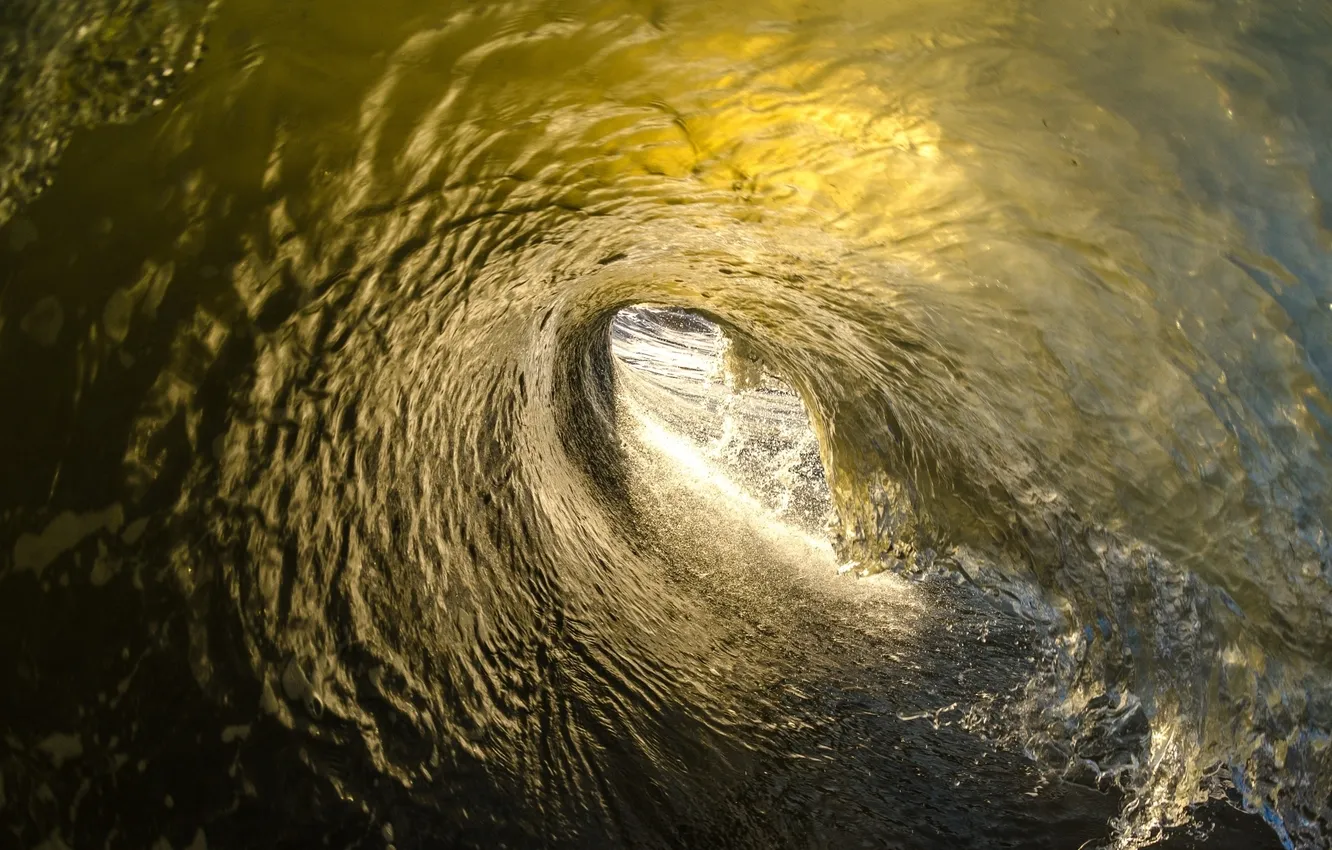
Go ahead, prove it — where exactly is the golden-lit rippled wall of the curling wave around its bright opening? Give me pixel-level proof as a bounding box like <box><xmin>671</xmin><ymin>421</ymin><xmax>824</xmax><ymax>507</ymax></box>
<box><xmin>0</xmin><ymin>1</ymin><xmax>1332</xmax><ymax>843</ymax></box>
